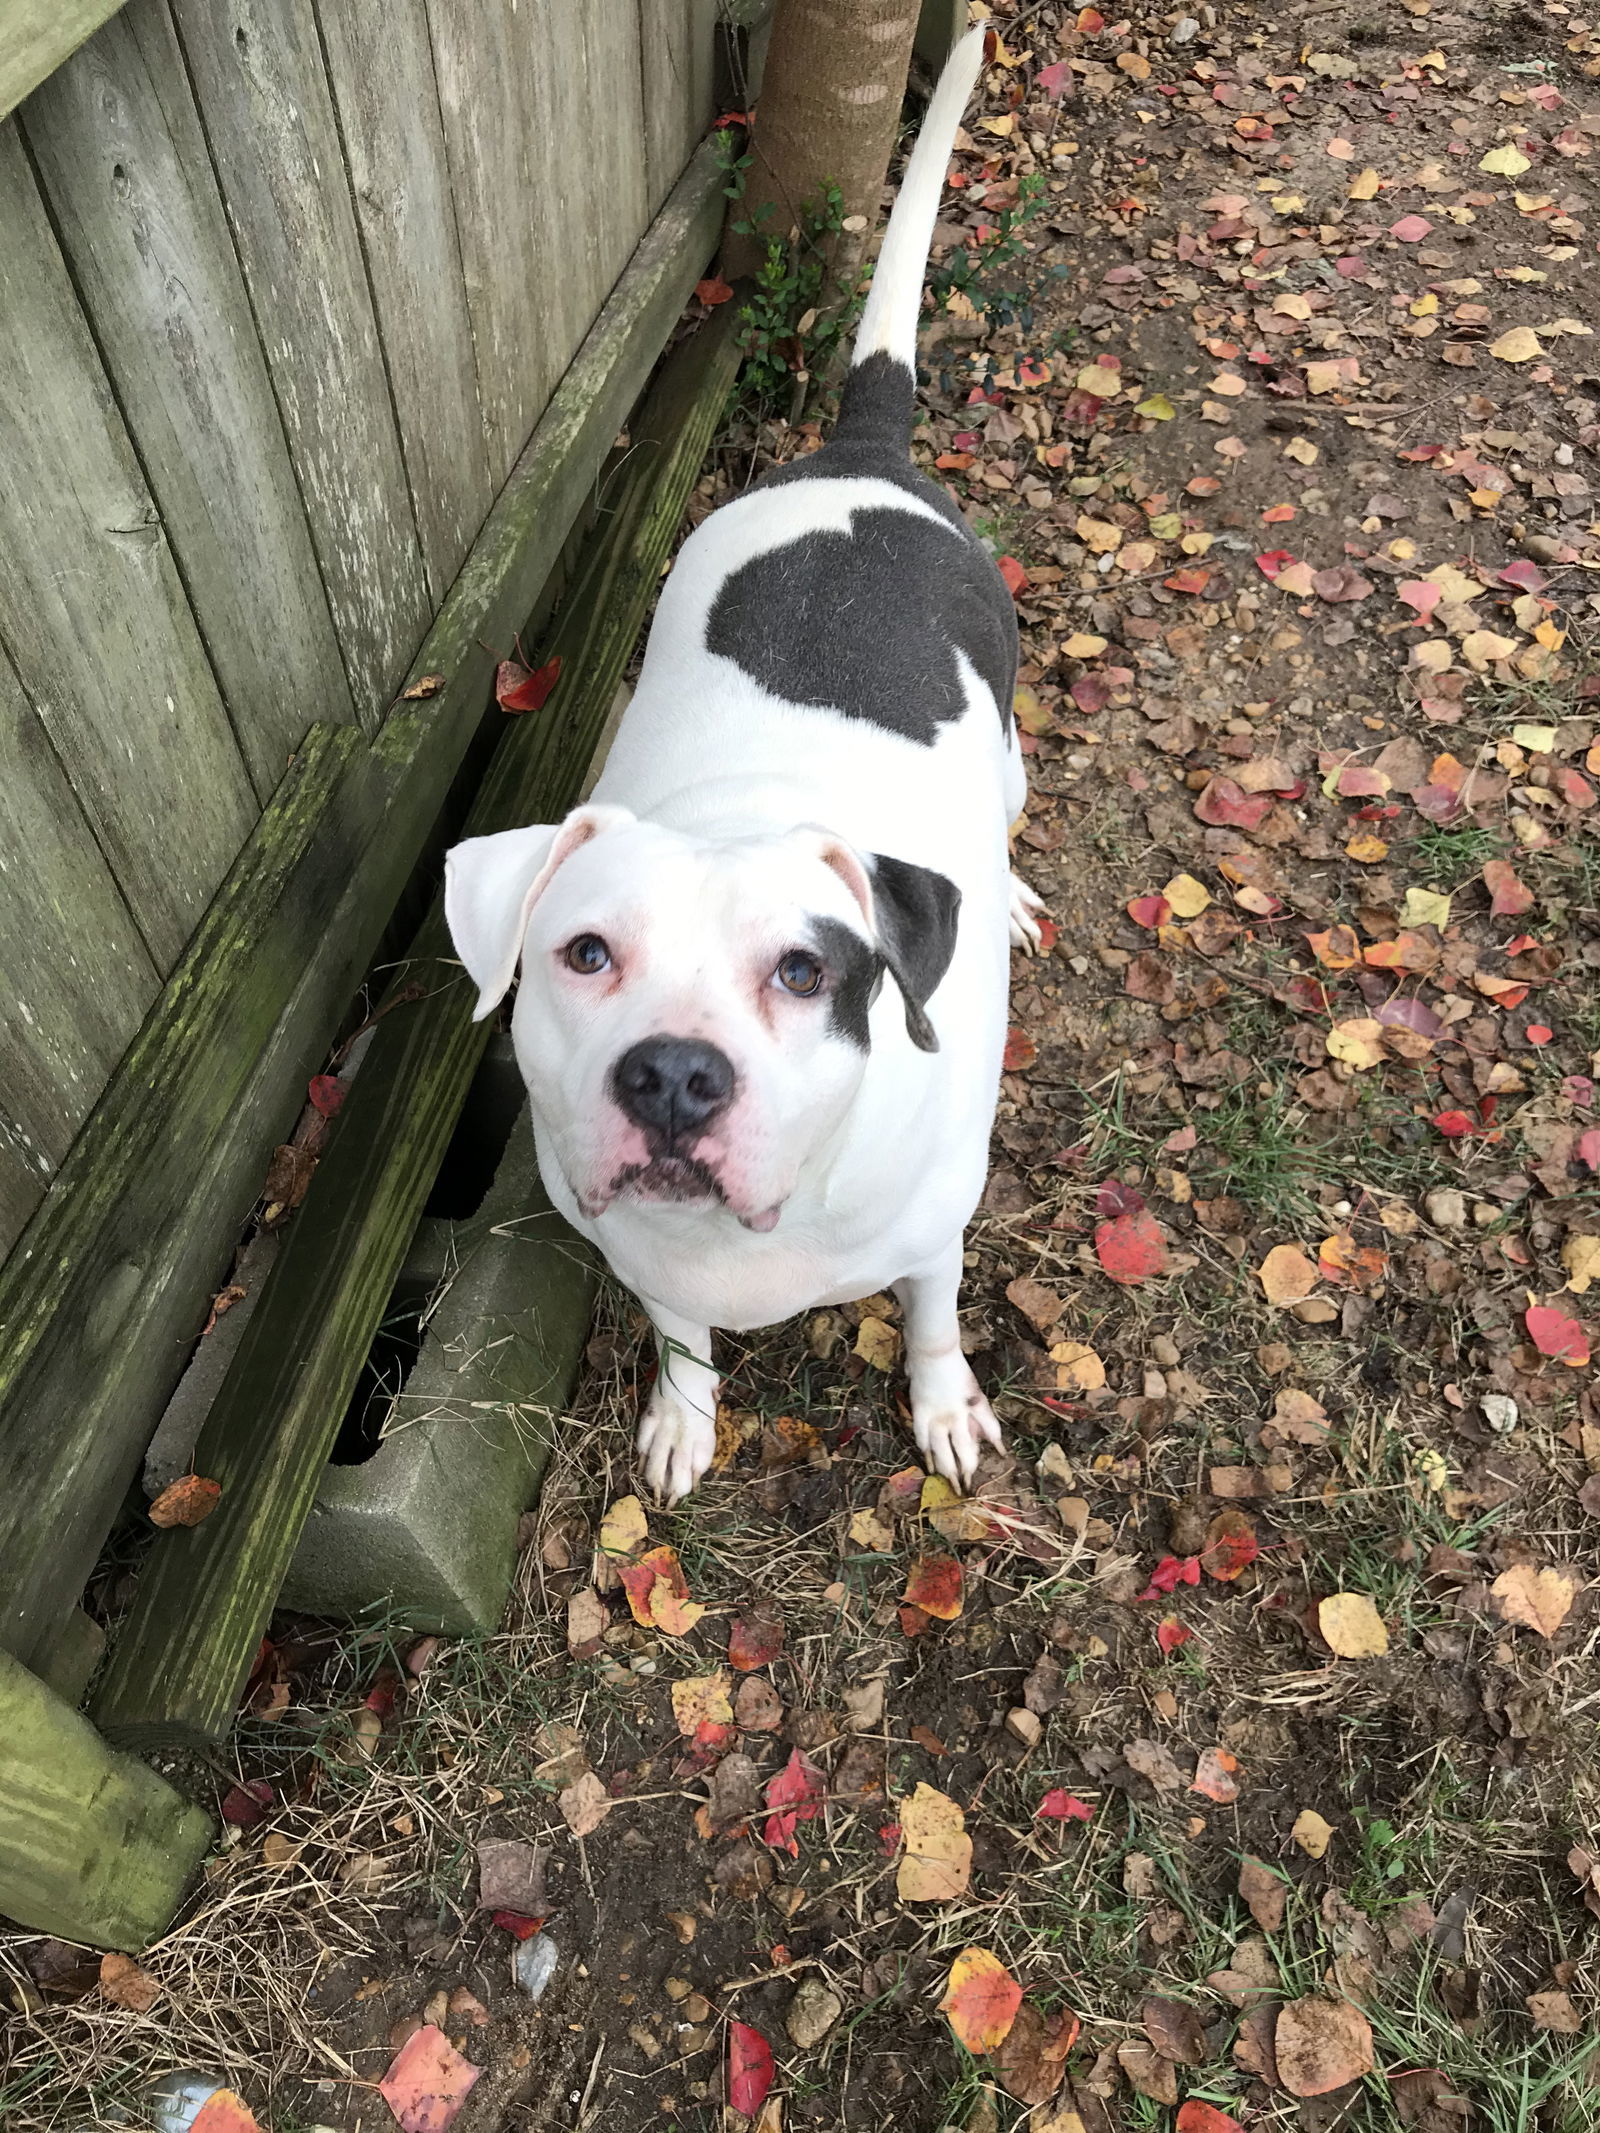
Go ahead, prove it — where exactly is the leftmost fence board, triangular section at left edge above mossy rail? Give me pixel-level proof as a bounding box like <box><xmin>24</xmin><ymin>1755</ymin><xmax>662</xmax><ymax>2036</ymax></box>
<box><xmin>0</xmin><ymin>653</ymin><xmax>160</xmax><ymax>1252</ymax></box>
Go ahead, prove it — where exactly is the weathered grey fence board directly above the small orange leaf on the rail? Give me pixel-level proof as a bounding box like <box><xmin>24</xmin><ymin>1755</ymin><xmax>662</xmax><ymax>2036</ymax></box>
<box><xmin>175</xmin><ymin>0</ymin><xmax>429</xmax><ymax>727</ymax></box>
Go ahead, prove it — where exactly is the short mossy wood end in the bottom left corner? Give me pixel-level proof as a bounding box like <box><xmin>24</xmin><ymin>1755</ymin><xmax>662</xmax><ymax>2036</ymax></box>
<box><xmin>0</xmin><ymin>1651</ymin><xmax>211</xmax><ymax>1950</ymax></box>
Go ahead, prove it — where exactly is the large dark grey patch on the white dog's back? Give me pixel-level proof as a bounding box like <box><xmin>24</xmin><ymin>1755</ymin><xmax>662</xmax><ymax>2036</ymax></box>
<box><xmin>706</xmin><ymin>503</ymin><xmax>1018</xmax><ymax>747</ymax></box>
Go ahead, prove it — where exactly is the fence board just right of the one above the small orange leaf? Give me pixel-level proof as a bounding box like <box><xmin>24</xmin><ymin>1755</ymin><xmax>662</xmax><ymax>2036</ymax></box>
<box><xmin>318</xmin><ymin>0</ymin><xmax>488</xmax><ymax>606</ymax></box>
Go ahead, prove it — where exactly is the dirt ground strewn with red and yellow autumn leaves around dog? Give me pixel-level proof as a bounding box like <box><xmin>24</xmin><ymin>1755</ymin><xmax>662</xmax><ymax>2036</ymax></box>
<box><xmin>0</xmin><ymin>0</ymin><xmax>1600</xmax><ymax>2133</ymax></box>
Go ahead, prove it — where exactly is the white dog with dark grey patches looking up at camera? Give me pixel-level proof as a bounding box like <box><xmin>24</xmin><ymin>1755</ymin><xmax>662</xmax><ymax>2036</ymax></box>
<box><xmin>446</xmin><ymin>32</ymin><xmax>1039</xmax><ymax>1499</ymax></box>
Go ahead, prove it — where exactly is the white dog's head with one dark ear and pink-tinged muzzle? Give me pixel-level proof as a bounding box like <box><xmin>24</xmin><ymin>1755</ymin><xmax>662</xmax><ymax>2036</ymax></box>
<box><xmin>444</xmin><ymin>806</ymin><xmax>960</xmax><ymax>1231</ymax></box>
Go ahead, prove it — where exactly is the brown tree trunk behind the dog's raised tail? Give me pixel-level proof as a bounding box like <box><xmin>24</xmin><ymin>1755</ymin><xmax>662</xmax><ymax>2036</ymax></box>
<box><xmin>725</xmin><ymin>0</ymin><xmax>917</xmax><ymax>309</ymax></box>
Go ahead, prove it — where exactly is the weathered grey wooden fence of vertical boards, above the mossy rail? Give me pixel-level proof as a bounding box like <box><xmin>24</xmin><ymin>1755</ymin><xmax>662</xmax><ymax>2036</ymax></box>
<box><xmin>0</xmin><ymin>0</ymin><xmax>715</xmax><ymax>1254</ymax></box>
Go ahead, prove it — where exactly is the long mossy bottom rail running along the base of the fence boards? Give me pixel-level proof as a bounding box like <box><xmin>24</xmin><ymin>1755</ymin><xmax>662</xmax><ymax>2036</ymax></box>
<box><xmin>0</xmin><ymin>147</ymin><xmax>721</xmax><ymax>1662</ymax></box>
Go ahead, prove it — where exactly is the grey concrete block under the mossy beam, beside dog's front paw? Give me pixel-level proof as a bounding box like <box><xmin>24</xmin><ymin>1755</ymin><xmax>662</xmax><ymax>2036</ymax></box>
<box><xmin>279</xmin><ymin>1109</ymin><xmax>597</xmax><ymax>1634</ymax></box>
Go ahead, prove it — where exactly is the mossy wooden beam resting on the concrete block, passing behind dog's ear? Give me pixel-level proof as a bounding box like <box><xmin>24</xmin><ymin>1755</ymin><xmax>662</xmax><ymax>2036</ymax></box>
<box><xmin>94</xmin><ymin>305</ymin><xmax>738</xmax><ymax>1745</ymax></box>
